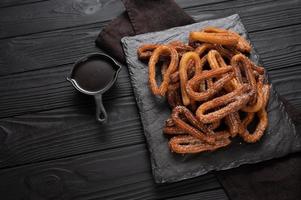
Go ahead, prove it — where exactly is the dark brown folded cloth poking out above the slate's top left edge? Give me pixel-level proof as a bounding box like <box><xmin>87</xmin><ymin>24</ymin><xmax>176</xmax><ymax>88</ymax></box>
<box><xmin>95</xmin><ymin>0</ymin><xmax>194</xmax><ymax>63</ymax></box>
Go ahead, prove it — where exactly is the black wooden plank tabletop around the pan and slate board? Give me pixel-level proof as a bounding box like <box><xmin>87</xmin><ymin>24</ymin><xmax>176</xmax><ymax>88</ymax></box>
<box><xmin>0</xmin><ymin>0</ymin><xmax>301</xmax><ymax>200</ymax></box>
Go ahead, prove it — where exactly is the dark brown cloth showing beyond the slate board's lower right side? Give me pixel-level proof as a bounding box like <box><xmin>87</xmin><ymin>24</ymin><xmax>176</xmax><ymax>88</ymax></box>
<box><xmin>216</xmin><ymin>96</ymin><xmax>301</xmax><ymax>200</ymax></box>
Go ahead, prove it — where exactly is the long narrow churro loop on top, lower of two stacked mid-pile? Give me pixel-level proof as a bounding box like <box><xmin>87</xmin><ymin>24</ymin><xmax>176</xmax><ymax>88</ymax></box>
<box><xmin>196</xmin><ymin>84</ymin><xmax>254</xmax><ymax>124</ymax></box>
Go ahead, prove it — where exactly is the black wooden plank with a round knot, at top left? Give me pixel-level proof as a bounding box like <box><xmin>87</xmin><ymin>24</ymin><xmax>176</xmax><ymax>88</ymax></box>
<box><xmin>0</xmin><ymin>0</ymin><xmax>124</xmax><ymax>38</ymax></box>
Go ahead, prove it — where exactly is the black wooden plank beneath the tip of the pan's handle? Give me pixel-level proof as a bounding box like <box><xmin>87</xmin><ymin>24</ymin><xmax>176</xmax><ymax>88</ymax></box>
<box><xmin>0</xmin><ymin>97</ymin><xmax>144</xmax><ymax>168</ymax></box>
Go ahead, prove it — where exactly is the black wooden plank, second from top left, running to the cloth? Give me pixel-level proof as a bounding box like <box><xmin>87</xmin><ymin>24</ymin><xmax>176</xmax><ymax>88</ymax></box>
<box><xmin>0</xmin><ymin>23</ymin><xmax>105</xmax><ymax>76</ymax></box>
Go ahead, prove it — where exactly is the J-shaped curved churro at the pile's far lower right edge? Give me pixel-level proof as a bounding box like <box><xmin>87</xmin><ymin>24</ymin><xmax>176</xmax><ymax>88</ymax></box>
<box><xmin>240</xmin><ymin>84</ymin><xmax>270</xmax><ymax>143</ymax></box>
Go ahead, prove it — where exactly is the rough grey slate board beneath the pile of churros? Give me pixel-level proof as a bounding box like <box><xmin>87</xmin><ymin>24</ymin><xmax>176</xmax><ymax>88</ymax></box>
<box><xmin>122</xmin><ymin>15</ymin><xmax>301</xmax><ymax>183</ymax></box>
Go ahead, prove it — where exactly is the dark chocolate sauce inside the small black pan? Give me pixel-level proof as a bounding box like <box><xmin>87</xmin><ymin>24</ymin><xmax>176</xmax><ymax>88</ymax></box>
<box><xmin>72</xmin><ymin>59</ymin><xmax>116</xmax><ymax>91</ymax></box>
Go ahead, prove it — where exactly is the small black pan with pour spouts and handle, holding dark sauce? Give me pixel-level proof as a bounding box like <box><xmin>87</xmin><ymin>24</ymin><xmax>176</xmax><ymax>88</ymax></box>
<box><xmin>67</xmin><ymin>53</ymin><xmax>121</xmax><ymax>123</ymax></box>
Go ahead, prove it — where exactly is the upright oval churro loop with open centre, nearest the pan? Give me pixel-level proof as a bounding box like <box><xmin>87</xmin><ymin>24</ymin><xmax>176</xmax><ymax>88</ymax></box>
<box><xmin>148</xmin><ymin>45</ymin><xmax>179</xmax><ymax>96</ymax></box>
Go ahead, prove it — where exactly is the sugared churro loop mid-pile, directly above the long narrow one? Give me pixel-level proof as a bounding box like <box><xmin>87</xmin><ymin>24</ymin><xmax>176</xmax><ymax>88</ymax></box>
<box><xmin>186</xmin><ymin>66</ymin><xmax>234</xmax><ymax>101</ymax></box>
